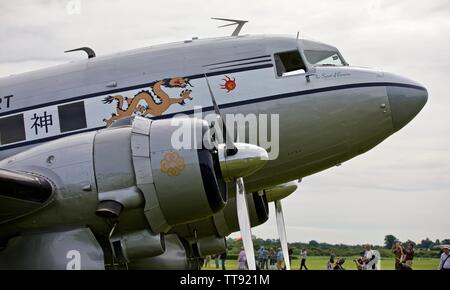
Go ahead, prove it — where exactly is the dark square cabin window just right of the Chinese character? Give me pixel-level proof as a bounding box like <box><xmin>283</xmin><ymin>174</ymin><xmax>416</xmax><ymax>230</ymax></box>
<box><xmin>58</xmin><ymin>102</ymin><xmax>87</xmax><ymax>133</ymax></box>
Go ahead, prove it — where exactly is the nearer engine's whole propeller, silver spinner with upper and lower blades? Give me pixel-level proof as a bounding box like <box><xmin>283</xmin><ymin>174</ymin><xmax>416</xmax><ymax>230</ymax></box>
<box><xmin>205</xmin><ymin>74</ymin><xmax>269</xmax><ymax>270</ymax></box>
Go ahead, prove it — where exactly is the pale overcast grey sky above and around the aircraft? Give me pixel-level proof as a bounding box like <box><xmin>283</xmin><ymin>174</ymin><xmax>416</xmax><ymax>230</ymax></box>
<box><xmin>0</xmin><ymin>0</ymin><xmax>450</xmax><ymax>244</ymax></box>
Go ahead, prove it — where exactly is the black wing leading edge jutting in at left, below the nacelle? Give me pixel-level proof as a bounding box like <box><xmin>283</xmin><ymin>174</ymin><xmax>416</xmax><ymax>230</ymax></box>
<box><xmin>0</xmin><ymin>169</ymin><xmax>53</xmax><ymax>224</ymax></box>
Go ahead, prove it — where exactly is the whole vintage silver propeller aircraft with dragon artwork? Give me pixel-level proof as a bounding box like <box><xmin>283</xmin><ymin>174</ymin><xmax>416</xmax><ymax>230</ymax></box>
<box><xmin>0</xmin><ymin>19</ymin><xmax>428</xmax><ymax>269</ymax></box>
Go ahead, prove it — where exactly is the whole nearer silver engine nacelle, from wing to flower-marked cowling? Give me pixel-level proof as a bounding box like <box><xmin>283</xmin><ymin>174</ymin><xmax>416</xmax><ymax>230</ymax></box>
<box><xmin>0</xmin><ymin>117</ymin><xmax>227</xmax><ymax>236</ymax></box>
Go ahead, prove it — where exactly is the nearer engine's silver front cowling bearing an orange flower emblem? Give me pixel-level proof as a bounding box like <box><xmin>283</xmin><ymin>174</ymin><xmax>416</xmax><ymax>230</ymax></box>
<box><xmin>131</xmin><ymin>118</ymin><xmax>227</xmax><ymax>232</ymax></box>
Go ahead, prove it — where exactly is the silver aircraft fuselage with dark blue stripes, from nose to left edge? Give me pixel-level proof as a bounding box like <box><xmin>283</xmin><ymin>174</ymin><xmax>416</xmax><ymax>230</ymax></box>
<box><xmin>0</xmin><ymin>36</ymin><xmax>427</xmax><ymax>192</ymax></box>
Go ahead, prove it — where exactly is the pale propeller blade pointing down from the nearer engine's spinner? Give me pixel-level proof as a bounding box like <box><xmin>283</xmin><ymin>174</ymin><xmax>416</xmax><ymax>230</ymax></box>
<box><xmin>236</xmin><ymin>177</ymin><xmax>256</xmax><ymax>270</ymax></box>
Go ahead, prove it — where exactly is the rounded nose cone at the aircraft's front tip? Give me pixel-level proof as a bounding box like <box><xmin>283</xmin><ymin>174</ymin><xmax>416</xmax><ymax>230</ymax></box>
<box><xmin>386</xmin><ymin>87</ymin><xmax>428</xmax><ymax>131</ymax></box>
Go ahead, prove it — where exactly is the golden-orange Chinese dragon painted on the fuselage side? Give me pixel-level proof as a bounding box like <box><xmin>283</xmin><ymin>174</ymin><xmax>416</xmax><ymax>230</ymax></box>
<box><xmin>103</xmin><ymin>77</ymin><xmax>192</xmax><ymax>127</ymax></box>
